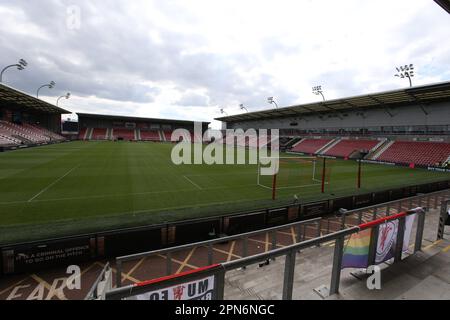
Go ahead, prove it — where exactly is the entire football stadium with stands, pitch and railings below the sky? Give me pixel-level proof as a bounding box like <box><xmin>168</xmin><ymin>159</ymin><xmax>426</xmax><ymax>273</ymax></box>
<box><xmin>0</xmin><ymin>1</ymin><xmax>450</xmax><ymax>311</ymax></box>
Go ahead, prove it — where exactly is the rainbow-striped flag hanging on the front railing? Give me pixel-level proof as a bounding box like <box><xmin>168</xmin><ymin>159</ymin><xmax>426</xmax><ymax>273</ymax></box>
<box><xmin>342</xmin><ymin>228</ymin><xmax>372</xmax><ymax>269</ymax></box>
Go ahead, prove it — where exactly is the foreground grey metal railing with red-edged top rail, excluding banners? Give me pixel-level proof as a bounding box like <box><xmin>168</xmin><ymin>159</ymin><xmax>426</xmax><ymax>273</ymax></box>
<box><xmin>105</xmin><ymin>208</ymin><xmax>426</xmax><ymax>300</ymax></box>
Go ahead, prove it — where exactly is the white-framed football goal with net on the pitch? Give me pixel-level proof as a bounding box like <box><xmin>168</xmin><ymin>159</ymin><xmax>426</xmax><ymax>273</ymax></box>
<box><xmin>257</xmin><ymin>157</ymin><xmax>328</xmax><ymax>190</ymax></box>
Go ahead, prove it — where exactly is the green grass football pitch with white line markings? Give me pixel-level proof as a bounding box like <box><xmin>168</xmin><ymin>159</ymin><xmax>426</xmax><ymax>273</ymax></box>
<box><xmin>0</xmin><ymin>142</ymin><xmax>450</xmax><ymax>244</ymax></box>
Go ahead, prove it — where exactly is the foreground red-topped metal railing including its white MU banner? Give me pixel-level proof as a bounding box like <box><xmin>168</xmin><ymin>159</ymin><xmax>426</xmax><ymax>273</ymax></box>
<box><xmin>105</xmin><ymin>208</ymin><xmax>426</xmax><ymax>300</ymax></box>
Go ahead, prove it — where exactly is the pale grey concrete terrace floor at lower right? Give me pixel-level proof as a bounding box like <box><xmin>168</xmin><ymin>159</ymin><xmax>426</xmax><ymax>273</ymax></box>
<box><xmin>225</xmin><ymin>210</ymin><xmax>450</xmax><ymax>300</ymax></box>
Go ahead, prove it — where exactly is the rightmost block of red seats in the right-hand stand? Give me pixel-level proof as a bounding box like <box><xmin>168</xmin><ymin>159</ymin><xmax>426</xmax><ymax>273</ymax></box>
<box><xmin>377</xmin><ymin>141</ymin><xmax>450</xmax><ymax>166</ymax></box>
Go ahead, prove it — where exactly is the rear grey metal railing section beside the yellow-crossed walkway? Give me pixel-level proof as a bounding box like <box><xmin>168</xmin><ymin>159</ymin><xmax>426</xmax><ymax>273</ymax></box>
<box><xmin>116</xmin><ymin>218</ymin><xmax>322</xmax><ymax>287</ymax></box>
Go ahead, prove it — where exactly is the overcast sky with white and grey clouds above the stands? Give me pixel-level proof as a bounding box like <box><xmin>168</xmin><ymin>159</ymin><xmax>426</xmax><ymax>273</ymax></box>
<box><xmin>0</xmin><ymin>0</ymin><xmax>450</xmax><ymax>127</ymax></box>
